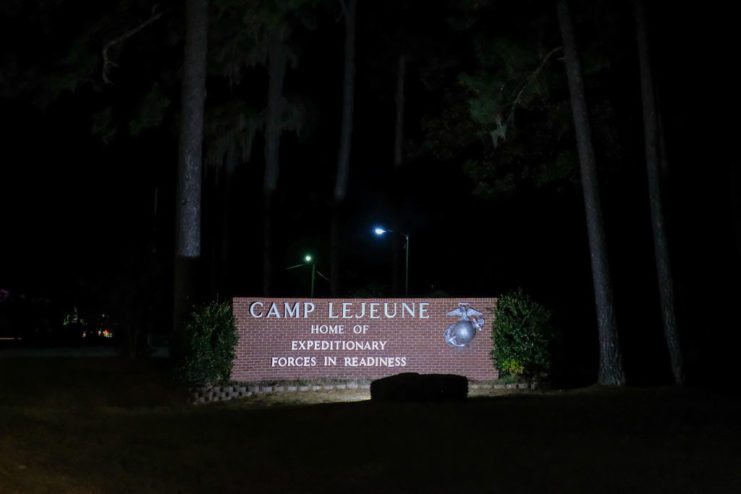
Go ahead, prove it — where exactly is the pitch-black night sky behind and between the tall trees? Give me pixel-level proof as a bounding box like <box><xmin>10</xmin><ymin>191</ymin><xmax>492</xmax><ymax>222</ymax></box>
<box><xmin>0</xmin><ymin>0</ymin><xmax>741</xmax><ymax>379</ymax></box>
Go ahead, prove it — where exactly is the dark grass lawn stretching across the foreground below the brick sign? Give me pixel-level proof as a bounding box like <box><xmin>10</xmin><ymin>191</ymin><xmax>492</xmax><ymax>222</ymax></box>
<box><xmin>0</xmin><ymin>355</ymin><xmax>741</xmax><ymax>494</ymax></box>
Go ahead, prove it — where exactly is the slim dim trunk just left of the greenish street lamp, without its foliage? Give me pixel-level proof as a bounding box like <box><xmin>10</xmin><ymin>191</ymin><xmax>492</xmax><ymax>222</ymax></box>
<box><xmin>262</xmin><ymin>32</ymin><xmax>287</xmax><ymax>296</ymax></box>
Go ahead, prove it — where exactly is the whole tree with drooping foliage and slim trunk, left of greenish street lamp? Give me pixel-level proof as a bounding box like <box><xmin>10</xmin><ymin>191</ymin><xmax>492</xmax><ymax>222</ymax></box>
<box><xmin>208</xmin><ymin>0</ymin><xmax>321</xmax><ymax>294</ymax></box>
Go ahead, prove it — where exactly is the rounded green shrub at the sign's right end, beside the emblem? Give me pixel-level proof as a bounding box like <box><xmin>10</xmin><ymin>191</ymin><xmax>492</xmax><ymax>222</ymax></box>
<box><xmin>491</xmin><ymin>288</ymin><xmax>553</xmax><ymax>378</ymax></box>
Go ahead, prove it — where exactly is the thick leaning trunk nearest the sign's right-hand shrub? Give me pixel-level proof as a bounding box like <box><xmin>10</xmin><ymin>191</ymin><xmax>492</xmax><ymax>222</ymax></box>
<box><xmin>556</xmin><ymin>0</ymin><xmax>625</xmax><ymax>385</ymax></box>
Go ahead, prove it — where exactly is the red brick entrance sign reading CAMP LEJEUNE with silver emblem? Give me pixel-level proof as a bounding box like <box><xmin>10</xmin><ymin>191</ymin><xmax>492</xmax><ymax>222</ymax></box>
<box><xmin>232</xmin><ymin>297</ymin><xmax>497</xmax><ymax>381</ymax></box>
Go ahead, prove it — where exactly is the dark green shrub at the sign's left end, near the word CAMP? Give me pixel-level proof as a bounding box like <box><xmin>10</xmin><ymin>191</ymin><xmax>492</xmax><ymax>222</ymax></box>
<box><xmin>178</xmin><ymin>301</ymin><xmax>238</xmax><ymax>386</ymax></box>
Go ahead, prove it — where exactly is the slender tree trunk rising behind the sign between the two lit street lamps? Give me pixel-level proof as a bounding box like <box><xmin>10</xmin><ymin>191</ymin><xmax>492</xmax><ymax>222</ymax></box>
<box><xmin>330</xmin><ymin>0</ymin><xmax>356</xmax><ymax>296</ymax></box>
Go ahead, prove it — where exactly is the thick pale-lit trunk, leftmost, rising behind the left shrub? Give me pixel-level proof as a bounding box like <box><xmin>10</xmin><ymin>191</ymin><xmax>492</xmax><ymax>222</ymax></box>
<box><xmin>173</xmin><ymin>0</ymin><xmax>208</xmax><ymax>344</ymax></box>
